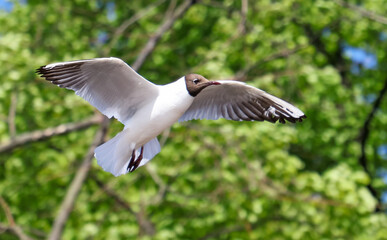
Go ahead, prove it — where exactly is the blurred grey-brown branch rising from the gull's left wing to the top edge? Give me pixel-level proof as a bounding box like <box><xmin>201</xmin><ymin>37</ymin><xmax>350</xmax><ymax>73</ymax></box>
<box><xmin>132</xmin><ymin>0</ymin><xmax>199</xmax><ymax>71</ymax></box>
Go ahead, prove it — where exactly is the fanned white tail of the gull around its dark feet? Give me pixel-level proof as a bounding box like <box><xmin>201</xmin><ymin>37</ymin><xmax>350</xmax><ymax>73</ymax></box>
<box><xmin>94</xmin><ymin>128</ymin><xmax>160</xmax><ymax>177</ymax></box>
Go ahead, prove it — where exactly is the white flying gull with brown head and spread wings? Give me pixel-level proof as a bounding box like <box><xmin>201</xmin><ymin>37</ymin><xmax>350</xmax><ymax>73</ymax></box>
<box><xmin>37</xmin><ymin>57</ymin><xmax>306</xmax><ymax>176</ymax></box>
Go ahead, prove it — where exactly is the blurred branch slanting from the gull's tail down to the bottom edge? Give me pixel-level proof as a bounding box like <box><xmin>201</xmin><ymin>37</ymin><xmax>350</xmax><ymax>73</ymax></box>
<box><xmin>48</xmin><ymin>117</ymin><xmax>110</xmax><ymax>240</ymax></box>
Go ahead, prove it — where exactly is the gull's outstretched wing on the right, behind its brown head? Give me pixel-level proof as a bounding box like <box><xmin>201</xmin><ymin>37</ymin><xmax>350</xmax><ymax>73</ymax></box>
<box><xmin>179</xmin><ymin>80</ymin><xmax>306</xmax><ymax>123</ymax></box>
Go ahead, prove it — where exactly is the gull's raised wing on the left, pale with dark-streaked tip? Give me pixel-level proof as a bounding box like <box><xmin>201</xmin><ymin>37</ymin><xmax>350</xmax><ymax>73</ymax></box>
<box><xmin>37</xmin><ymin>58</ymin><xmax>158</xmax><ymax>124</ymax></box>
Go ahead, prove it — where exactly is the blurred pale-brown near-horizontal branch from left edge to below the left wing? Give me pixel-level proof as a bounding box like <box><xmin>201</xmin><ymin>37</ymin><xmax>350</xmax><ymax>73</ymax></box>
<box><xmin>0</xmin><ymin>114</ymin><xmax>103</xmax><ymax>153</ymax></box>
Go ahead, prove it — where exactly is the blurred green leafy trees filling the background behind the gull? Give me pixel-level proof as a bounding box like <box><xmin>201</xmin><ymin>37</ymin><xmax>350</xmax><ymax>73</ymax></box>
<box><xmin>0</xmin><ymin>0</ymin><xmax>387</xmax><ymax>239</ymax></box>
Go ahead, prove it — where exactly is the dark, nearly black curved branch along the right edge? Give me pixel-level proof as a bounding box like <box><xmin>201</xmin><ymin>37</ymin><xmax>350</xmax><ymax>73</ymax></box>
<box><xmin>359</xmin><ymin>78</ymin><xmax>387</xmax><ymax>212</ymax></box>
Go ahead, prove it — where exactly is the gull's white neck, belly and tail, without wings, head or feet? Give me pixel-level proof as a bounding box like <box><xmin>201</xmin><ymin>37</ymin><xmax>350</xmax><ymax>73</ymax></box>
<box><xmin>95</xmin><ymin>79</ymin><xmax>193</xmax><ymax>176</ymax></box>
